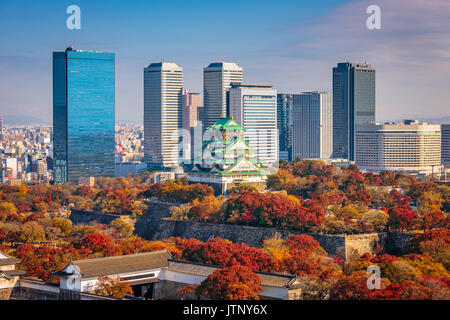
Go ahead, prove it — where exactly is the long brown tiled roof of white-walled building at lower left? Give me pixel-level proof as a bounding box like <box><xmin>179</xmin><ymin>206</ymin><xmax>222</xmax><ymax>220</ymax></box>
<box><xmin>54</xmin><ymin>250</ymin><xmax>172</xmax><ymax>278</ymax></box>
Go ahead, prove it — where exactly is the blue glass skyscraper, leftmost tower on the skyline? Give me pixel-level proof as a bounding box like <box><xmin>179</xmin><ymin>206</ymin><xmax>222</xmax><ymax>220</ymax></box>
<box><xmin>53</xmin><ymin>47</ymin><xmax>115</xmax><ymax>183</ymax></box>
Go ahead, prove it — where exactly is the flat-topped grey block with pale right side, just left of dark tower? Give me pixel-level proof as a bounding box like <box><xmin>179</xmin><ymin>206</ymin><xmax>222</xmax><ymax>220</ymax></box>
<box><xmin>292</xmin><ymin>91</ymin><xmax>333</xmax><ymax>159</ymax></box>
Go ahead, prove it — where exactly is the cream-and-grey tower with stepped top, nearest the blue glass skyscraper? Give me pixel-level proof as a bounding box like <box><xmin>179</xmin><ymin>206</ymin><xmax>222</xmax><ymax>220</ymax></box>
<box><xmin>144</xmin><ymin>62</ymin><xmax>183</xmax><ymax>167</ymax></box>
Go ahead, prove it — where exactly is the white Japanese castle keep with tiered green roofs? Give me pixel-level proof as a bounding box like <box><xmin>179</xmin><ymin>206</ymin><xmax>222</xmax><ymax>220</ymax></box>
<box><xmin>187</xmin><ymin>118</ymin><xmax>268</xmax><ymax>194</ymax></box>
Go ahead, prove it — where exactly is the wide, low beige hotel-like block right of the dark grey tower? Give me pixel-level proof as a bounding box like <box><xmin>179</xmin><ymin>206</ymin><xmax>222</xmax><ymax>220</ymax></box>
<box><xmin>355</xmin><ymin>120</ymin><xmax>441</xmax><ymax>175</ymax></box>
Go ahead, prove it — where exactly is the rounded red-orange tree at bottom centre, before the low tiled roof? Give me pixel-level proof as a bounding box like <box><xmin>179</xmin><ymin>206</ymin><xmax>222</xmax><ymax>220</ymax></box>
<box><xmin>197</xmin><ymin>265</ymin><xmax>263</xmax><ymax>300</ymax></box>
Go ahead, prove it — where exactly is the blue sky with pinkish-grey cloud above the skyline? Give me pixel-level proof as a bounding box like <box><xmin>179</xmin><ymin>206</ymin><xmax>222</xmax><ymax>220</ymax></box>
<box><xmin>0</xmin><ymin>0</ymin><xmax>450</xmax><ymax>123</ymax></box>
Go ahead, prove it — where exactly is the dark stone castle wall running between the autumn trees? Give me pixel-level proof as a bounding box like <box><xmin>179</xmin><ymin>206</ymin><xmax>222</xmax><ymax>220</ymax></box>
<box><xmin>70</xmin><ymin>201</ymin><xmax>413</xmax><ymax>261</ymax></box>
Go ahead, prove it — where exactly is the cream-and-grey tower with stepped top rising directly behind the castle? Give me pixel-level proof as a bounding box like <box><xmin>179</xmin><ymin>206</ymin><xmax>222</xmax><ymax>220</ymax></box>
<box><xmin>203</xmin><ymin>61</ymin><xmax>242</xmax><ymax>129</ymax></box>
